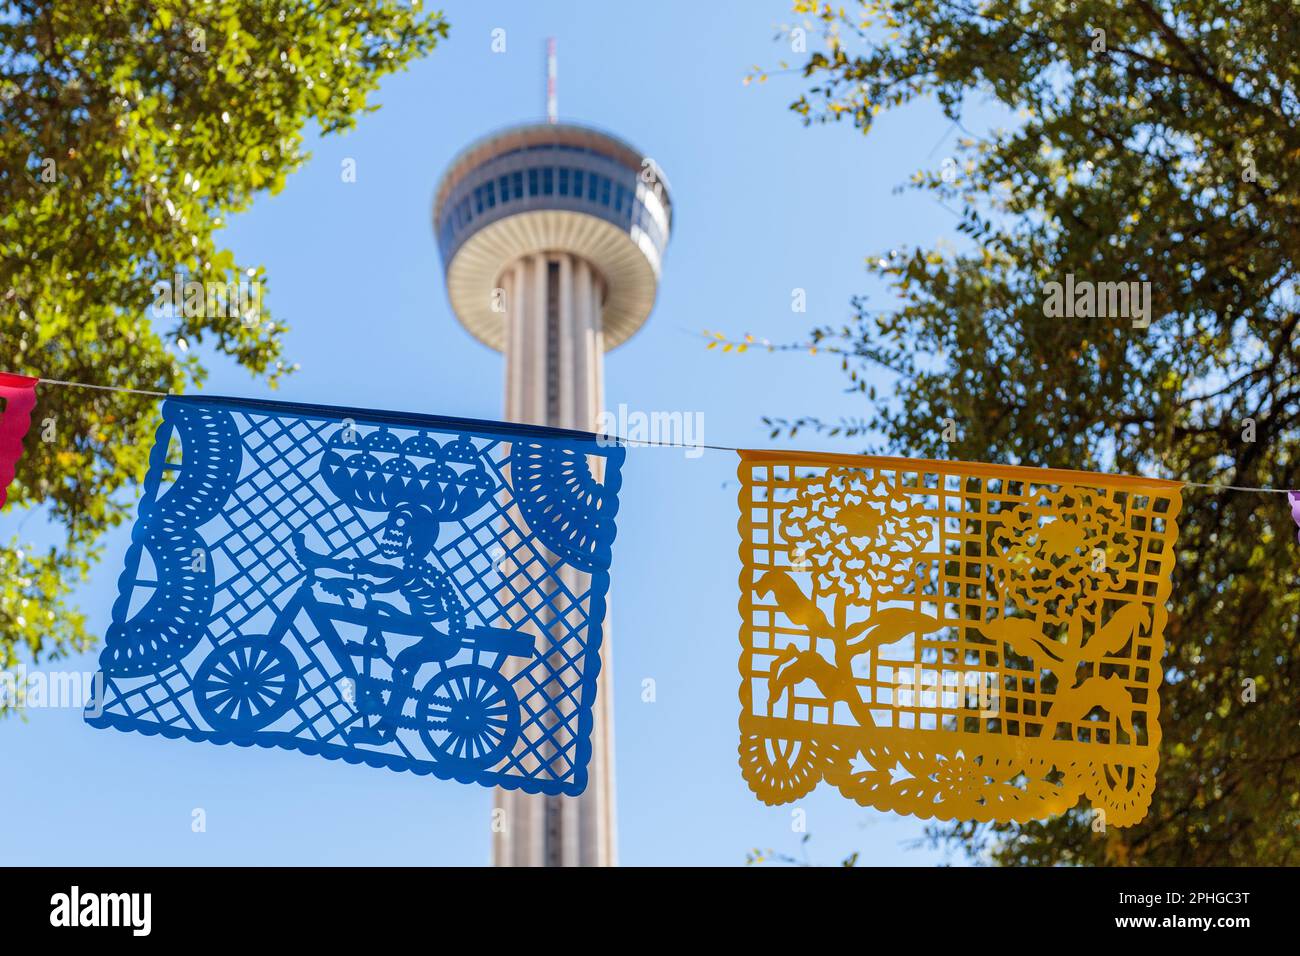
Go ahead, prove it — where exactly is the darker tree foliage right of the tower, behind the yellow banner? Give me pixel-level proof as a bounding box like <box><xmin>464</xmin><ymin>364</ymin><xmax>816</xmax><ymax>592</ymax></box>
<box><xmin>772</xmin><ymin>0</ymin><xmax>1300</xmax><ymax>865</ymax></box>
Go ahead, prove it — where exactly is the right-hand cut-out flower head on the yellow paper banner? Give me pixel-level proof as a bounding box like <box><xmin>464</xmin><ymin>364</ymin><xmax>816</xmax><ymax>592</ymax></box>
<box><xmin>993</xmin><ymin>486</ymin><xmax>1136</xmax><ymax>623</ymax></box>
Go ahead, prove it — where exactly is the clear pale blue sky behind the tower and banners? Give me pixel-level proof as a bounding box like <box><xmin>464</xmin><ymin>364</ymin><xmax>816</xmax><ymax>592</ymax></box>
<box><xmin>0</xmin><ymin>0</ymin><xmax>977</xmax><ymax>865</ymax></box>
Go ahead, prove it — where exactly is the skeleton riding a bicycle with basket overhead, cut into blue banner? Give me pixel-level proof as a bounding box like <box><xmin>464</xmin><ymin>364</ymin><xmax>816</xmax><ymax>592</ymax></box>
<box><xmin>194</xmin><ymin>429</ymin><xmax>536</xmax><ymax>770</ymax></box>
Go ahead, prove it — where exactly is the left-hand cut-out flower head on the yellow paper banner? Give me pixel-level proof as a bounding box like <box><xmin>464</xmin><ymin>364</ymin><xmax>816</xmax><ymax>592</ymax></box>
<box><xmin>780</xmin><ymin>468</ymin><xmax>935</xmax><ymax>606</ymax></box>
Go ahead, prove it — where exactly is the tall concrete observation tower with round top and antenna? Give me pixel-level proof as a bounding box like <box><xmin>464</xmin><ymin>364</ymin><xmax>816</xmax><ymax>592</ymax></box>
<box><xmin>433</xmin><ymin>40</ymin><xmax>672</xmax><ymax>866</ymax></box>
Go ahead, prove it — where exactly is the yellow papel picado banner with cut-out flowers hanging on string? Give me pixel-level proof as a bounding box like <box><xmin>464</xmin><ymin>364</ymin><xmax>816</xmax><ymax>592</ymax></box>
<box><xmin>740</xmin><ymin>451</ymin><xmax>1180</xmax><ymax>826</ymax></box>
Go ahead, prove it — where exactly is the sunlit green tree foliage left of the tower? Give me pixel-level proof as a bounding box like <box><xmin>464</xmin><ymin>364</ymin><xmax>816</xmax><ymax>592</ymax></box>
<box><xmin>0</xmin><ymin>0</ymin><xmax>447</xmax><ymax>697</ymax></box>
